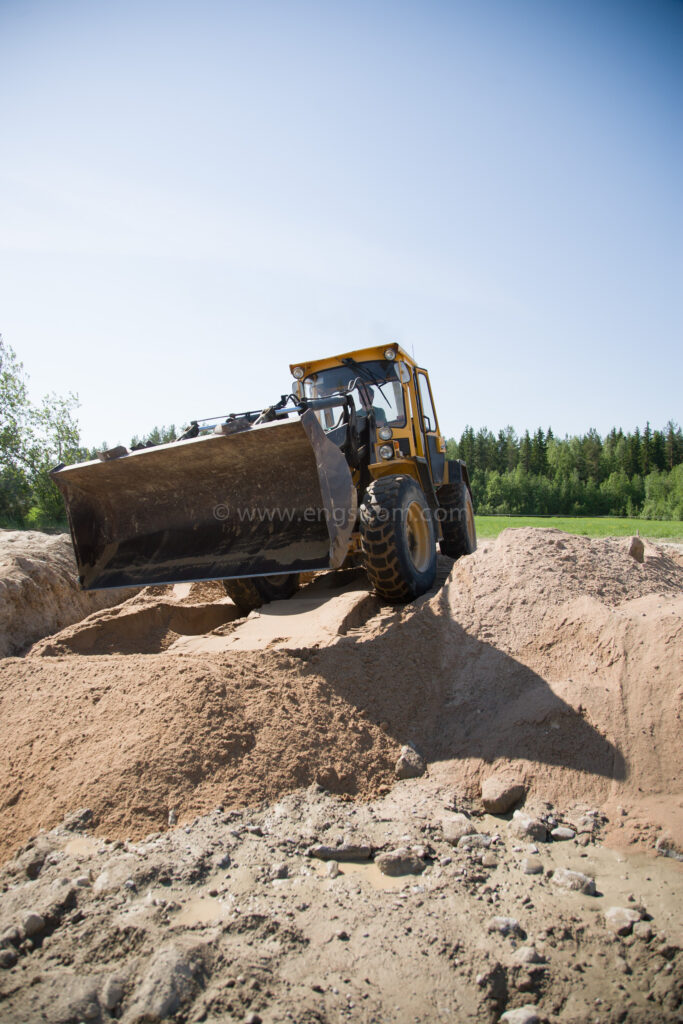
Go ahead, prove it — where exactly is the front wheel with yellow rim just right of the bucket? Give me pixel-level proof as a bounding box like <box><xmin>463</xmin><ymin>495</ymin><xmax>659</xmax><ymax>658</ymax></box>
<box><xmin>360</xmin><ymin>476</ymin><xmax>436</xmax><ymax>601</ymax></box>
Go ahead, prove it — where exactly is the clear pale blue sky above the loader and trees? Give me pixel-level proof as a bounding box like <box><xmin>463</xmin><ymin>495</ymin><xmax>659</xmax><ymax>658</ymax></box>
<box><xmin>0</xmin><ymin>0</ymin><xmax>683</xmax><ymax>445</ymax></box>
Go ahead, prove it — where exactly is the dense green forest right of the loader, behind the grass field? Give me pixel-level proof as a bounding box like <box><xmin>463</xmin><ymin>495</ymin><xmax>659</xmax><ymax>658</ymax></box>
<box><xmin>446</xmin><ymin>420</ymin><xmax>683</xmax><ymax>519</ymax></box>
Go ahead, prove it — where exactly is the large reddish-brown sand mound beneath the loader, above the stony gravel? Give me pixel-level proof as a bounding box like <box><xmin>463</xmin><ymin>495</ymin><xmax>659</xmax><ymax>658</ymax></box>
<box><xmin>0</xmin><ymin>529</ymin><xmax>683</xmax><ymax>864</ymax></box>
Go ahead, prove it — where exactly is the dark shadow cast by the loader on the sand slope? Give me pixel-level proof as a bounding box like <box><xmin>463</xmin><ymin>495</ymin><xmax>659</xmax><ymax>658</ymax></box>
<box><xmin>303</xmin><ymin>591</ymin><xmax>628</xmax><ymax>780</ymax></box>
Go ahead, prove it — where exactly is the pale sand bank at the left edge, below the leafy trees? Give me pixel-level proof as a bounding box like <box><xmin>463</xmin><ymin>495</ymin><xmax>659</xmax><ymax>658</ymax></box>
<box><xmin>0</xmin><ymin>530</ymin><xmax>132</xmax><ymax>657</ymax></box>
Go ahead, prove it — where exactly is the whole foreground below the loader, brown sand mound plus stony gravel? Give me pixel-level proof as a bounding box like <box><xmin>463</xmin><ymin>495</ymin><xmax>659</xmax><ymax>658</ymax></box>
<box><xmin>0</xmin><ymin>530</ymin><xmax>683</xmax><ymax>1024</ymax></box>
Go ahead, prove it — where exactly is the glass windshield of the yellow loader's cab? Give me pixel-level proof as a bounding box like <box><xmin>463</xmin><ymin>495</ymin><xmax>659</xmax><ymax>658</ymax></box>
<box><xmin>303</xmin><ymin>359</ymin><xmax>405</xmax><ymax>430</ymax></box>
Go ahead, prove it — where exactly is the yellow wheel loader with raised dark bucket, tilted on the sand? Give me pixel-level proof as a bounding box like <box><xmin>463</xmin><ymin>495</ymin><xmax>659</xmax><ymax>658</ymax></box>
<box><xmin>52</xmin><ymin>344</ymin><xmax>476</xmax><ymax>612</ymax></box>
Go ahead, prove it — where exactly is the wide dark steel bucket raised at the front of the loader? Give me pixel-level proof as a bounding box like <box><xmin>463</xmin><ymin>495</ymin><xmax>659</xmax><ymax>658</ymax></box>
<box><xmin>52</xmin><ymin>411</ymin><xmax>356</xmax><ymax>590</ymax></box>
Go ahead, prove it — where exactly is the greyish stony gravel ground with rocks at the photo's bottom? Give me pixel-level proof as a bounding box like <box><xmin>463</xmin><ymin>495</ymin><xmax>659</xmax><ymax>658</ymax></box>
<box><xmin>0</xmin><ymin>777</ymin><xmax>683</xmax><ymax>1024</ymax></box>
